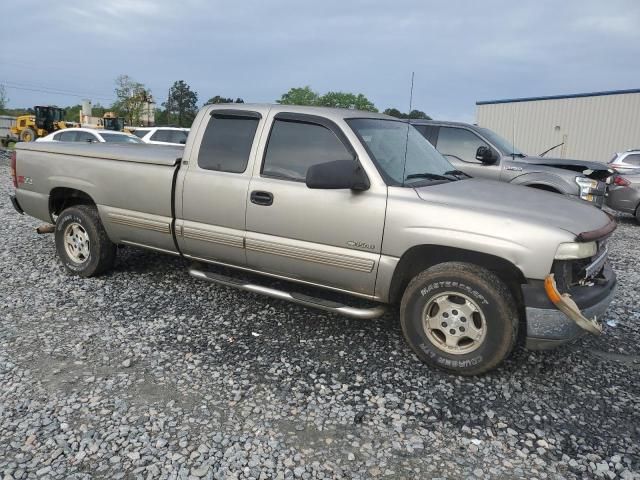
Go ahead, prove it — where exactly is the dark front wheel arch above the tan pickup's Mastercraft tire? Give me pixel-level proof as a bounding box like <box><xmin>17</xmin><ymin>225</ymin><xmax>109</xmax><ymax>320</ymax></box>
<box><xmin>389</xmin><ymin>245</ymin><xmax>527</xmax><ymax>304</ymax></box>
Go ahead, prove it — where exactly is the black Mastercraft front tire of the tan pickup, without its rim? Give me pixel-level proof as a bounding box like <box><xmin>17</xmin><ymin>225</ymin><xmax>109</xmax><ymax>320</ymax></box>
<box><xmin>400</xmin><ymin>262</ymin><xmax>519</xmax><ymax>375</ymax></box>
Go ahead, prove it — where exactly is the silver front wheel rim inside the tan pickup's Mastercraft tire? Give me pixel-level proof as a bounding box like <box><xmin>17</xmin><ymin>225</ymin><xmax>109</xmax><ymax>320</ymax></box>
<box><xmin>422</xmin><ymin>292</ymin><xmax>487</xmax><ymax>355</ymax></box>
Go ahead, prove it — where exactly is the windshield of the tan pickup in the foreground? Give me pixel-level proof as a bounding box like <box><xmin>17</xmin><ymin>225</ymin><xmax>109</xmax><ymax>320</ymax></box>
<box><xmin>347</xmin><ymin>118</ymin><xmax>457</xmax><ymax>185</ymax></box>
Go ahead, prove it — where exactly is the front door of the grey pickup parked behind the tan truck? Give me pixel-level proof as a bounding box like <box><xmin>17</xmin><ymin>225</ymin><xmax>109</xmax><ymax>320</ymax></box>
<box><xmin>436</xmin><ymin>127</ymin><xmax>502</xmax><ymax>180</ymax></box>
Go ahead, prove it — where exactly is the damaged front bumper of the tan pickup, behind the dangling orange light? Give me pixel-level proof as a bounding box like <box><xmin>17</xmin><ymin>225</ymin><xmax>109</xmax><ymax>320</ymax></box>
<box><xmin>522</xmin><ymin>264</ymin><xmax>616</xmax><ymax>350</ymax></box>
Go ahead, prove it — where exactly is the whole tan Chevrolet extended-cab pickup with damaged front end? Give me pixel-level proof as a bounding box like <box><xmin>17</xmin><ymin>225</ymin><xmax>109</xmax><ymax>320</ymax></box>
<box><xmin>11</xmin><ymin>104</ymin><xmax>616</xmax><ymax>375</ymax></box>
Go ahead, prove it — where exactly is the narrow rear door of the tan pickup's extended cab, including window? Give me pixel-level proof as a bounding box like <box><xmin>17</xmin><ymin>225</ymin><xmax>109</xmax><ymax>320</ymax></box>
<box><xmin>176</xmin><ymin>107</ymin><xmax>269</xmax><ymax>266</ymax></box>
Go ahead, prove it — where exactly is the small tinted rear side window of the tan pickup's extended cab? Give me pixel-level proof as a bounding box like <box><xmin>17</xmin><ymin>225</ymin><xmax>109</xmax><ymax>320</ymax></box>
<box><xmin>198</xmin><ymin>115</ymin><xmax>260</xmax><ymax>173</ymax></box>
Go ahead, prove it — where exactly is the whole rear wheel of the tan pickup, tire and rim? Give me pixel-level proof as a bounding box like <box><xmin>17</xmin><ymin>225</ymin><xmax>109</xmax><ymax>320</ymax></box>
<box><xmin>55</xmin><ymin>205</ymin><xmax>116</xmax><ymax>277</ymax></box>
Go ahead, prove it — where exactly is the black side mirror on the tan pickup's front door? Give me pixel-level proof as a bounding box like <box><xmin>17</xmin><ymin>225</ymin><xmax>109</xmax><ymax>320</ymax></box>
<box><xmin>306</xmin><ymin>159</ymin><xmax>370</xmax><ymax>191</ymax></box>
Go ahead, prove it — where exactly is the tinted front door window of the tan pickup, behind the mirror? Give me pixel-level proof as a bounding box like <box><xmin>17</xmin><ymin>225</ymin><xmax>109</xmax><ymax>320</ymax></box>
<box><xmin>262</xmin><ymin>119</ymin><xmax>353</xmax><ymax>182</ymax></box>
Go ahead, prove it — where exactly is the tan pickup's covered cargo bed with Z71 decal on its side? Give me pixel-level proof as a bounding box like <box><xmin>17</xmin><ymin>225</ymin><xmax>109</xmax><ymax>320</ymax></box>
<box><xmin>16</xmin><ymin>142</ymin><xmax>183</xmax><ymax>252</ymax></box>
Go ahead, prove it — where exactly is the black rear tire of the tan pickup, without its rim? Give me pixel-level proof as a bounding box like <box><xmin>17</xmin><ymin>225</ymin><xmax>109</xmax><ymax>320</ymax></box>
<box><xmin>55</xmin><ymin>205</ymin><xmax>116</xmax><ymax>277</ymax></box>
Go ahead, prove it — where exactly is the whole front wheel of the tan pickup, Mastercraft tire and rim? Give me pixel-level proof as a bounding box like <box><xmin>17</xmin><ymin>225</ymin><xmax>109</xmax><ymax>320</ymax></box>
<box><xmin>400</xmin><ymin>262</ymin><xmax>518</xmax><ymax>375</ymax></box>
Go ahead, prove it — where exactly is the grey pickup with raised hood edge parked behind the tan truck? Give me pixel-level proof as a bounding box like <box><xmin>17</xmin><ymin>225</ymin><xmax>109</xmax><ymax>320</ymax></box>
<box><xmin>411</xmin><ymin>120</ymin><xmax>614</xmax><ymax>208</ymax></box>
